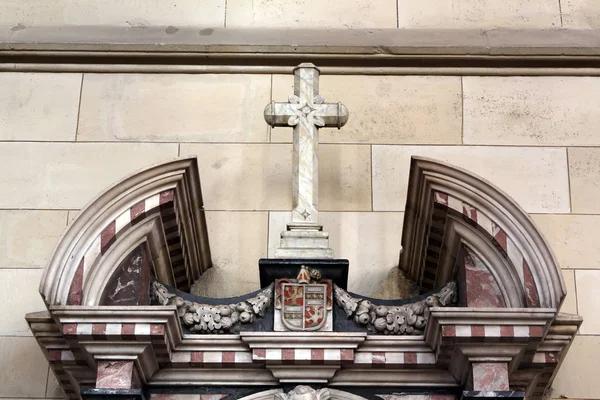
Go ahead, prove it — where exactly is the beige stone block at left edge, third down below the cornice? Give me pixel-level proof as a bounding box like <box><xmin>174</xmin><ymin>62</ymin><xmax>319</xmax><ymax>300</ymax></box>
<box><xmin>0</xmin><ymin>210</ymin><xmax>67</xmax><ymax>268</ymax></box>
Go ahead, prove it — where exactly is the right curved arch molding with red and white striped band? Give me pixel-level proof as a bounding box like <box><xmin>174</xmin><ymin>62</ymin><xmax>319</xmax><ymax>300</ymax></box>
<box><xmin>400</xmin><ymin>157</ymin><xmax>566</xmax><ymax>309</ymax></box>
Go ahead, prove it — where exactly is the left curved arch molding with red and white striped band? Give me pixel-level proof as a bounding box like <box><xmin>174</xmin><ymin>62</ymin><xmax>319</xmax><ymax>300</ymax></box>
<box><xmin>40</xmin><ymin>158</ymin><xmax>211</xmax><ymax>306</ymax></box>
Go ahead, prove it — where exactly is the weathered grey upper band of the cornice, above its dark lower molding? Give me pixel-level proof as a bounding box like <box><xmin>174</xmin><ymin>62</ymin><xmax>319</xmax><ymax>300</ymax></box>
<box><xmin>0</xmin><ymin>26</ymin><xmax>600</xmax><ymax>60</ymax></box>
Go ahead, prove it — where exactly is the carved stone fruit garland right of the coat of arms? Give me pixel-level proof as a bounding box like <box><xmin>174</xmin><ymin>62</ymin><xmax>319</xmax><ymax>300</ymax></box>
<box><xmin>333</xmin><ymin>282</ymin><xmax>457</xmax><ymax>335</ymax></box>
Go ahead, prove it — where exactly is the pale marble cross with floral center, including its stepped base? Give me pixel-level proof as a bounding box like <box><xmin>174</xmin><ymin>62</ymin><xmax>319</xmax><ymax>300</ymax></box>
<box><xmin>265</xmin><ymin>63</ymin><xmax>348</xmax><ymax>257</ymax></box>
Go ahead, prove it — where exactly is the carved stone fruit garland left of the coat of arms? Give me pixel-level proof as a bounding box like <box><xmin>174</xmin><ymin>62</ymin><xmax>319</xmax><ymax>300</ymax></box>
<box><xmin>152</xmin><ymin>281</ymin><xmax>273</xmax><ymax>333</ymax></box>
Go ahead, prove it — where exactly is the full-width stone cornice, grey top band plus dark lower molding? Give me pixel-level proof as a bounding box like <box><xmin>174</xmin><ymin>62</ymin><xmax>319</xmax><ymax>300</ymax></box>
<box><xmin>0</xmin><ymin>26</ymin><xmax>600</xmax><ymax>75</ymax></box>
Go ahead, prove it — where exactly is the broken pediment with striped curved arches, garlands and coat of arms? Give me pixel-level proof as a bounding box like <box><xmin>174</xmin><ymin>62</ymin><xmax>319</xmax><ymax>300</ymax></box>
<box><xmin>27</xmin><ymin>158</ymin><xmax>581</xmax><ymax>400</ymax></box>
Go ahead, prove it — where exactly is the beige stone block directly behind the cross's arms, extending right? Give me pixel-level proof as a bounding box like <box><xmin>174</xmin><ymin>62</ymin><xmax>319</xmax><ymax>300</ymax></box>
<box><xmin>271</xmin><ymin>75</ymin><xmax>462</xmax><ymax>144</ymax></box>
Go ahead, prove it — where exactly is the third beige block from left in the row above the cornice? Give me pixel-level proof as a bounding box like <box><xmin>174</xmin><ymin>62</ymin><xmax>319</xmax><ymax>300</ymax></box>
<box><xmin>398</xmin><ymin>0</ymin><xmax>560</xmax><ymax>29</ymax></box>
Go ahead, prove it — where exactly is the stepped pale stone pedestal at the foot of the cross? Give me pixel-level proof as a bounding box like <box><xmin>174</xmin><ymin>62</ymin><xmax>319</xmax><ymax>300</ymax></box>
<box><xmin>275</xmin><ymin>223</ymin><xmax>333</xmax><ymax>258</ymax></box>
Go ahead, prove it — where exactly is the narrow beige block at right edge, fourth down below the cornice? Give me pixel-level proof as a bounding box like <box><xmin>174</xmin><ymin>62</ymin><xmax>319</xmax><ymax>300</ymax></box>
<box><xmin>575</xmin><ymin>264</ymin><xmax>600</xmax><ymax>335</ymax></box>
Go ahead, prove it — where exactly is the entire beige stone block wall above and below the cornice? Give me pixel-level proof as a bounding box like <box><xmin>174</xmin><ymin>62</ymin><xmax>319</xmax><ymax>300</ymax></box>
<box><xmin>0</xmin><ymin>0</ymin><xmax>600</xmax><ymax>399</ymax></box>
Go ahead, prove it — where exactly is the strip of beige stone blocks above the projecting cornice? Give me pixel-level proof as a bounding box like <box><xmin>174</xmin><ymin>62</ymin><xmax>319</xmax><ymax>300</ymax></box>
<box><xmin>0</xmin><ymin>0</ymin><xmax>600</xmax><ymax>29</ymax></box>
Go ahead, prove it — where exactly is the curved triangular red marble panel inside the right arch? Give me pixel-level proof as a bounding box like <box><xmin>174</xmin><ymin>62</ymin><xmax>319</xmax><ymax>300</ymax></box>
<box><xmin>463</xmin><ymin>248</ymin><xmax>504</xmax><ymax>307</ymax></box>
